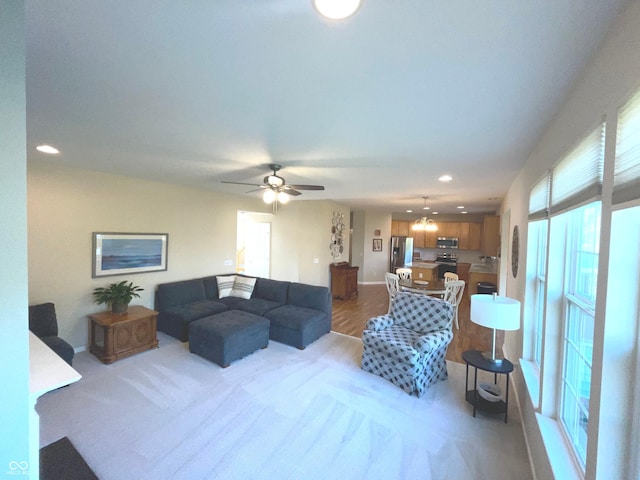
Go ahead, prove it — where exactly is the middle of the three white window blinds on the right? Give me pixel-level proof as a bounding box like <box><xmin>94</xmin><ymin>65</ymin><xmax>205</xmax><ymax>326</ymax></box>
<box><xmin>551</xmin><ymin>123</ymin><xmax>605</xmax><ymax>214</ymax></box>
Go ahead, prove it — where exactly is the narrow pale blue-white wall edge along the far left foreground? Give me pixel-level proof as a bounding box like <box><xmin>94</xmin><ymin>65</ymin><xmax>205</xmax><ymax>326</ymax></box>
<box><xmin>0</xmin><ymin>0</ymin><xmax>30</xmax><ymax>472</ymax></box>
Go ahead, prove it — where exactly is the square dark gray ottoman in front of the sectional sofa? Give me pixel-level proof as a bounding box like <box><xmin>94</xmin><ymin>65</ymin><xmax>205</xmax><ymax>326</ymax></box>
<box><xmin>189</xmin><ymin>310</ymin><xmax>269</xmax><ymax>368</ymax></box>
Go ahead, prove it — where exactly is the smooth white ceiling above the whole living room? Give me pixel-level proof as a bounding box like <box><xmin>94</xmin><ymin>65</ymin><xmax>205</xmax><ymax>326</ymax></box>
<box><xmin>26</xmin><ymin>0</ymin><xmax>626</xmax><ymax>213</ymax></box>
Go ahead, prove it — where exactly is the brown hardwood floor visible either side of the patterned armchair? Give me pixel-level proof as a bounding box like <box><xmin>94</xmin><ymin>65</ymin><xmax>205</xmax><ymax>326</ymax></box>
<box><xmin>332</xmin><ymin>284</ymin><xmax>504</xmax><ymax>363</ymax></box>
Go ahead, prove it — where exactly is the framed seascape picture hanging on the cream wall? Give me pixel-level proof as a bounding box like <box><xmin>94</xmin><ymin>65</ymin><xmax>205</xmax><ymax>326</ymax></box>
<box><xmin>91</xmin><ymin>232</ymin><xmax>169</xmax><ymax>278</ymax></box>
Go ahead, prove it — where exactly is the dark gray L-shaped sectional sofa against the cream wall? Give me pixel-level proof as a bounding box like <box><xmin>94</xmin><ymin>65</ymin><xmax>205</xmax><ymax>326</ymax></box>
<box><xmin>155</xmin><ymin>274</ymin><xmax>331</xmax><ymax>349</ymax></box>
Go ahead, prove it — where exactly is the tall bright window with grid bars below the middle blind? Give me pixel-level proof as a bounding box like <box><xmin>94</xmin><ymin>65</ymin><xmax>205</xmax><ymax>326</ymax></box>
<box><xmin>559</xmin><ymin>202</ymin><xmax>600</xmax><ymax>468</ymax></box>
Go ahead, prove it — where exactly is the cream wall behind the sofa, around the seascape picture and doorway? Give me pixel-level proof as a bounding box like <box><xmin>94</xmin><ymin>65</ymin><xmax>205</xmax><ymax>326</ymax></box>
<box><xmin>28</xmin><ymin>160</ymin><xmax>348</xmax><ymax>347</ymax></box>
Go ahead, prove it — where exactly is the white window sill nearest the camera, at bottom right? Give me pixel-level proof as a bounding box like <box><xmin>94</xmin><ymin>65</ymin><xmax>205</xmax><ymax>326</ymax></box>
<box><xmin>536</xmin><ymin>413</ymin><xmax>584</xmax><ymax>480</ymax></box>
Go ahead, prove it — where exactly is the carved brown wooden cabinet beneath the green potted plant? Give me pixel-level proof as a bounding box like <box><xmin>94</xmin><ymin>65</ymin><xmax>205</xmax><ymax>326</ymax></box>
<box><xmin>89</xmin><ymin>305</ymin><xmax>158</xmax><ymax>363</ymax></box>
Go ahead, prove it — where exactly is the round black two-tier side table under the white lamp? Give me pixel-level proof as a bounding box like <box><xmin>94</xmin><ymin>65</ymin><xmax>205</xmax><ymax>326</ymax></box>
<box><xmin>462</xmin><ymin>350</ymin><xmax>513</xmax><ymax>423</ymax></box>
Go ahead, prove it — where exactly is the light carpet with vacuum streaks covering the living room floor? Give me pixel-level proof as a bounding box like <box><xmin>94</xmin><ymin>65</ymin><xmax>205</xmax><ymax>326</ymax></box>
<box><xmin>37</xmin><ymin>333</ymin><xmax>532</xmax><ymax>480</ymax></box>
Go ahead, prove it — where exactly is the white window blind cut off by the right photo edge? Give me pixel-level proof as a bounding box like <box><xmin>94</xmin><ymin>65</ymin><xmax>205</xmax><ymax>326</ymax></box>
<box><xmin>612</xmin><ymin>90</ymin><xmax>640</xmax><ymax>204</ymax></box>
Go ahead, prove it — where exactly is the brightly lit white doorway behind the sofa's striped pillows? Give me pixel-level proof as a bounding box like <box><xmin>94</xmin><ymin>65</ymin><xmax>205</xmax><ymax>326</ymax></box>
<box><xmin>236</xmin><ymin>211</ymin><xmax>271</xmax><ymax>278</ymax></box>
